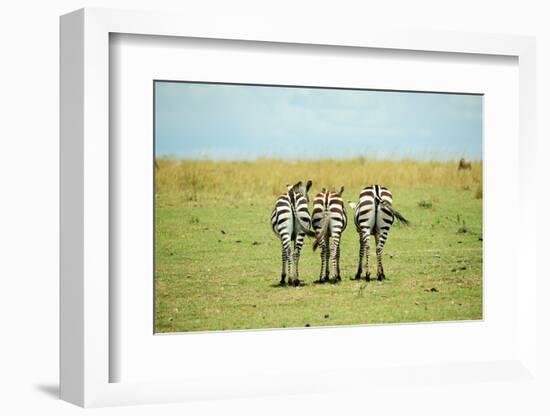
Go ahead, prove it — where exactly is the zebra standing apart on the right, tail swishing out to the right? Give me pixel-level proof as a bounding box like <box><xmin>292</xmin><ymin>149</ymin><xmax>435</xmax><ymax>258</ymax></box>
<box><xmin>348</xmin><ymin>185</ymin><xmax>409</xmax><ymax>282</ymax></box>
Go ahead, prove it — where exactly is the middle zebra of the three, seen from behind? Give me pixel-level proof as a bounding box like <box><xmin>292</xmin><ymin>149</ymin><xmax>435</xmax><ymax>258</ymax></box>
<box><xmin>312</xmin><ymin>186</ymin><xmax>348</xmax><ymax>283</ymax></box>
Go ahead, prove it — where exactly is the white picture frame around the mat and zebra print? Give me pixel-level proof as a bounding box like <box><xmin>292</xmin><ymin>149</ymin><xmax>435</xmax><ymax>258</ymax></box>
<box><xmin>60</xmin><ymin>9</ymin><xmax>538</xmax><ymax>407</ymax></box>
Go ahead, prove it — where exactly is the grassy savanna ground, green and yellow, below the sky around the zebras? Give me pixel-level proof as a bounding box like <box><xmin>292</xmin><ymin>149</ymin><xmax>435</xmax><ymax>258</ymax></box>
<box><xmin>155</xmin><ymin>159</ymin><xmax>483</xmax><ymax>332</ymax></box>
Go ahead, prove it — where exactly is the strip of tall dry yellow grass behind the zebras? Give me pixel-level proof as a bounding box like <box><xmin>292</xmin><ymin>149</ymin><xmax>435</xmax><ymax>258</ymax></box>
<box><xmin>156</xmin><ymin>159</ymin><xmax>482</xmax><ymax>206</ymax></box>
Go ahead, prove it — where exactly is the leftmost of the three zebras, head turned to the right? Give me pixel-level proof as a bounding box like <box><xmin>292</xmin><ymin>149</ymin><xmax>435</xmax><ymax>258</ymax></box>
<box><xmin>271</xmin><ymin>180</ymin><xmax>315</xmax><ymax>286</ymax></box>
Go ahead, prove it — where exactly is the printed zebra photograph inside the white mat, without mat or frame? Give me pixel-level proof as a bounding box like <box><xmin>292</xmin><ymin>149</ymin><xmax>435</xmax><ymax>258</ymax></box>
<box><xmin>153</xmin><ymin>80</ymin><xmax>483</xmax><ymax>333</ymax></box>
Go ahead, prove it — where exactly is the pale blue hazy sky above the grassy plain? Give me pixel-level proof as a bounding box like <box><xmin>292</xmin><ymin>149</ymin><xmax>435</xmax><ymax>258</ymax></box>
<box><xmin>155</xmin><ymin>81</ymin><xmax>483</xmax><ymax>160</ymax></box>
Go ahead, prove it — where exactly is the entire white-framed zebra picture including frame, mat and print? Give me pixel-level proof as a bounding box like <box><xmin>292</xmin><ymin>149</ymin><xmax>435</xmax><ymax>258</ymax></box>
<box><xmin>61</xmin><ymin>9</ymin><xmax>537</xmax><ymax>406</ymax></box>
